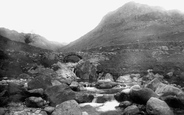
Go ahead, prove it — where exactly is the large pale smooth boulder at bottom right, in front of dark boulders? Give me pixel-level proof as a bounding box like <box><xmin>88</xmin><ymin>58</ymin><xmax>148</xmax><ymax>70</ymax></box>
<box><xmin>146</xmin><ymin>97</ymin><xmax>174</xmax><ymax>115</ymax></box>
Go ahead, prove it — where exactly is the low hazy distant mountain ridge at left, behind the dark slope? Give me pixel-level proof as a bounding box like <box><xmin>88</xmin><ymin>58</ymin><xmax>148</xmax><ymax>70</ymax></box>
<box><xmin>0</xmin><ymin>28</ymin><xmax>64</xmax><ymax>51</ymax></box>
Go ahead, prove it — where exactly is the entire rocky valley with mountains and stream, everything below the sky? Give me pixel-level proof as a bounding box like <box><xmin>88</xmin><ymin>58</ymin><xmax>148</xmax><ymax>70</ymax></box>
<box><xmin>0</xmin><ymin>2</ymin><xmax>184</xmax><ymax>115</ymax></box>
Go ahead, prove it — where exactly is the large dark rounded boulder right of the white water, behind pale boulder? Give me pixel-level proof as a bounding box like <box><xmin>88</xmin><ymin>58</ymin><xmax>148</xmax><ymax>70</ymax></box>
<box><xmin>129</xmin><ymin>87</ymin><xmax>158</xmax><ymax>104</ymax></box>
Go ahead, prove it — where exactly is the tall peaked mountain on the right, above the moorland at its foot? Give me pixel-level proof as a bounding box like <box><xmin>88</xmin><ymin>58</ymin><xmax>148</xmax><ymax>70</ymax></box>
<box><xmin>61</xmin><ymin>2</ymin><xmax>184</xmax><ymax>51</ymax></box>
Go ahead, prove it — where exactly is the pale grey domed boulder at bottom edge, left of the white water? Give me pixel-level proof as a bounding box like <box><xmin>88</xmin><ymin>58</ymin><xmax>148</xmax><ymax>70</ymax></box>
<box><xmin>51</xmin><ymin>100</ymin><xmax>82</xmax><ymax>115</ymax></box>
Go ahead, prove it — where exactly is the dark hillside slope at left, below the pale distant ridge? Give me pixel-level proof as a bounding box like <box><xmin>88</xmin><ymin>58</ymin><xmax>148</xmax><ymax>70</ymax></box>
<box><xmin>0</xmin><ymin>35</ymin><xmax>59</xmax><ymax>79</ymax></box>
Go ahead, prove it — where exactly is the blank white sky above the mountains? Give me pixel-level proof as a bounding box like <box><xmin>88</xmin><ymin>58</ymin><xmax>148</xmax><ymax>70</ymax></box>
<box><xmin>0</xmin><ymin>0</ymin><xmax>184</xmax><ymax>43</ymax></box>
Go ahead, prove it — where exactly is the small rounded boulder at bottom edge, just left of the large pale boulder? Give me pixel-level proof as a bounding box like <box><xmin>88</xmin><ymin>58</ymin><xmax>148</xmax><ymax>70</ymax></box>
<box><xmin>123</xmin><ymin>105</ymin><xmax>140</xmax><ymax>115</ymax></box>
